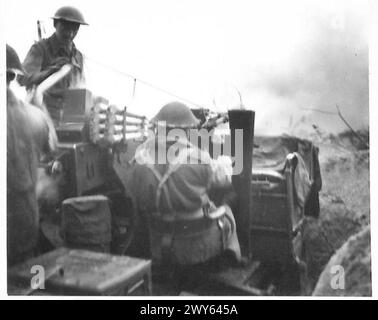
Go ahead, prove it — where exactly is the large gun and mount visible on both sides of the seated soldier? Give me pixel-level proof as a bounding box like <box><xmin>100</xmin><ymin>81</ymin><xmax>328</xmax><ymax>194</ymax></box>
<box><xmin>36</xmin><ymin>94</ymin><xmax>314</xmax><ymax>295</ymax></box>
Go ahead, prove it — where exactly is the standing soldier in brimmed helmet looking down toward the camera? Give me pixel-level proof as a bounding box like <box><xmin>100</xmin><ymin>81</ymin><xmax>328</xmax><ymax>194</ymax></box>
<box><xmin>23</xmin><ymin>7</ymin><xmax>87</xmax><ymax>121</ymax></box>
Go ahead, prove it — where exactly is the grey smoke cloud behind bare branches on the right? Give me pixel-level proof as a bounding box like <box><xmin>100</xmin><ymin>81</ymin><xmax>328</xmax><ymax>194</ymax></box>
<box><xmin>243</xmin><ymin>9</ymin><xmax>369</xmax><ymax>134</ymax></box>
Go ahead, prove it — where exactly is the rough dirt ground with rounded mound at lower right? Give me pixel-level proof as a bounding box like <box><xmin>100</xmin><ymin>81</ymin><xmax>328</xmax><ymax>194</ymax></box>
<box><xmin>304</xmin><ymin>134</ymin><xmax>371</xmax><ymax>296</ymax></box>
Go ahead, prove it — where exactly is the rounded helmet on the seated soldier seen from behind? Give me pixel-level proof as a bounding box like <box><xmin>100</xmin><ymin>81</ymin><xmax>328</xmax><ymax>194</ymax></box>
<box><xmin>151</xmin><ymin>101</ymin><xmax>199</xmax><ymax>128</ymax></box>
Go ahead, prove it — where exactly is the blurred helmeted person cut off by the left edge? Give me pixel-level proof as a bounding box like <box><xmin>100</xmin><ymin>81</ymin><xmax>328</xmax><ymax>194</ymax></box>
<box><xmin>6</xmin><ymin>45</ymin><xmax>56</xmax><ymax>265</ymax></box>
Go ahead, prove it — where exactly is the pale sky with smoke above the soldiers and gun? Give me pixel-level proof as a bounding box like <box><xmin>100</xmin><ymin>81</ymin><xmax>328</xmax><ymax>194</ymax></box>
<box><xmin>5</xmin><ymin>0</ymin><xmax>371</xmax><ymax>132</ymax></box>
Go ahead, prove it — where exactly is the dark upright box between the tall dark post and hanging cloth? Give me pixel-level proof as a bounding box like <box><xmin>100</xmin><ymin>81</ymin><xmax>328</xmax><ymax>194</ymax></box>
<box><xmin>250</xmin><ymin>166</ymin><xmax>294</xmax><ymax>268</ymax></box>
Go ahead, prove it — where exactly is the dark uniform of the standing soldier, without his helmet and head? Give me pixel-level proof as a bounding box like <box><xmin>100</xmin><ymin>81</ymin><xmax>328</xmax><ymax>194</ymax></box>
<box><xmin>23</xmin><ymin>33</ymin><xmax>85</xmax><ymax>120</ymax></box>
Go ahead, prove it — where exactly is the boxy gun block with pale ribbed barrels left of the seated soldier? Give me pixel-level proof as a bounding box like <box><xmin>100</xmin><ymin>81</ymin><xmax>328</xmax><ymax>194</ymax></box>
<box><xmin>52</xmin><ymin>89</ymin><xmax>147</xmax><ymax>197</ymax></box>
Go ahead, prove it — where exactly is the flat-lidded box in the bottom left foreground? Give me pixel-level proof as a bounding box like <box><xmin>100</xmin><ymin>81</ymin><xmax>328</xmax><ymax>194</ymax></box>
<box><xmin>8</xmin><ymin>248</ymin><xmax>152</xmax><ymax>295</ymax></box>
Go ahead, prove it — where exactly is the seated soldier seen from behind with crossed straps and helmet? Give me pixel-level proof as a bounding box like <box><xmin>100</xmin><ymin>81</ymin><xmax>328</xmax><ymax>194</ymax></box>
<box><xmin>126</xmin><ymin>102</ymin><xmax>240</xmax><ymax>276</ymax></box>
